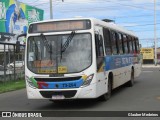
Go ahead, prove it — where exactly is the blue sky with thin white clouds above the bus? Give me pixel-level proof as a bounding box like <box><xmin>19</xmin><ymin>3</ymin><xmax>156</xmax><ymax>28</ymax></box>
<box><xmin>19</xmin><ymin>0</ymin><xmax>160</xmax><ymax>47</ymax></box>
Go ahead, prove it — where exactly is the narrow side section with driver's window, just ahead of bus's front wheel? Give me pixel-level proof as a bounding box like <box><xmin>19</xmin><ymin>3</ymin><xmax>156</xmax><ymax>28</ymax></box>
<box><xmin>95</xmin><ymin>29</ymin><xmax>107</xmax><ymax>94</ymax></box>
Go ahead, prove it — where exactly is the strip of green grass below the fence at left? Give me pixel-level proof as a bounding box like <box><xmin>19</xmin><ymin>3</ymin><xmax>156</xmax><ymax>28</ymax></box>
<box><xmin>0</xmin><ymin>80</ymin><xmax>25</xmax><ymax>93</ymax></box>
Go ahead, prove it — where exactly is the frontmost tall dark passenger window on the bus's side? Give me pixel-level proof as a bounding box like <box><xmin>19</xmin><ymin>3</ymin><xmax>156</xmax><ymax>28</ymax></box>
<box><xmin>103</xmin><ymin>28</ymin><xmax>112</xmax><ymax>55</ymax></box>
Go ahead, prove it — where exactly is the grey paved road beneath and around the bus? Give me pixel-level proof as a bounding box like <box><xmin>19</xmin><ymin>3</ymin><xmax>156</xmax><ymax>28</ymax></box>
<box><xmin>0</xmin><ymin>68</ymin><xmax>160</xmax><ymax>120</ymax></box>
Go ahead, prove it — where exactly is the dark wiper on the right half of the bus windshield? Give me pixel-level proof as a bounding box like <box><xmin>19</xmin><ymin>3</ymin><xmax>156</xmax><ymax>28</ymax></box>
<box><xmin>61</xmin><ymin>31</ymin><xmax>75</xmax><ymax>53</ymax></box>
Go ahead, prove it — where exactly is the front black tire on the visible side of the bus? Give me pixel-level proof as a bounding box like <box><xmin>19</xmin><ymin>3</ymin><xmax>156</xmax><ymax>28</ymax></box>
<box><xmin>100</xmin><ymin>78</ymin><xmax>112</xmax><ymax>101</ymax></box>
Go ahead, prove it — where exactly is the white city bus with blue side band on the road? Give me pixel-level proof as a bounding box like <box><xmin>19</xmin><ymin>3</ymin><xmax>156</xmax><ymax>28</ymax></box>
<box><xmin>19</xmin><ymin>18</ymin><xmax>141</xmax><ymax>102</ymax></box>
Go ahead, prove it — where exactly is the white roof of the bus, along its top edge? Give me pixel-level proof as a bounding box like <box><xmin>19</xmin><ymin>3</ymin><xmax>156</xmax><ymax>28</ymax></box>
<box><xmin>31</xmin><ymin>17</ymin><xmax>137</xmax><ymax>37</ymax></box>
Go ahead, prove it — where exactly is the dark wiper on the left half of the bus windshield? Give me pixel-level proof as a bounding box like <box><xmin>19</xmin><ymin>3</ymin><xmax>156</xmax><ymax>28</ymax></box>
<box><xmin>40</xmin><ymin>33</ymin><xmax>52</xmax><ymax>61</ymax></box>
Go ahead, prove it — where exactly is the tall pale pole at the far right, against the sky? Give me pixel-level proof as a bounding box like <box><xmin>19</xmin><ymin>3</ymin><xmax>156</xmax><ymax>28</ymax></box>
<box><xmin>154</xmin><ymin>0</ymin><xmax>157</xmax><ymax>66</ymax></box>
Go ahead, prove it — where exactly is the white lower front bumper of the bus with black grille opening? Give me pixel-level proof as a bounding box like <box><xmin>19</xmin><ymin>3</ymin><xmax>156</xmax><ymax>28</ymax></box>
<box><xmin>27</xmin><ymin>84</ymin><xmax>98</xmax><ymax>100</ymax></box>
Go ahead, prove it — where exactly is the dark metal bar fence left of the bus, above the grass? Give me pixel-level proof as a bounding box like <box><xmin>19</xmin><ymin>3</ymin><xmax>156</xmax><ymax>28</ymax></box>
<box><xmin>0</xmin><ymin>42</ymin><xmax>25</xmax><ymax>83</ymax></box>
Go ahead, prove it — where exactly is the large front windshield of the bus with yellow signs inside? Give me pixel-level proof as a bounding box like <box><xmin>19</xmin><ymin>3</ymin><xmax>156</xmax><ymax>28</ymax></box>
<box><xmin>27</xmin><ymin>33</ymin><xmax>92</xmax><ymax>74</ymax></box>
